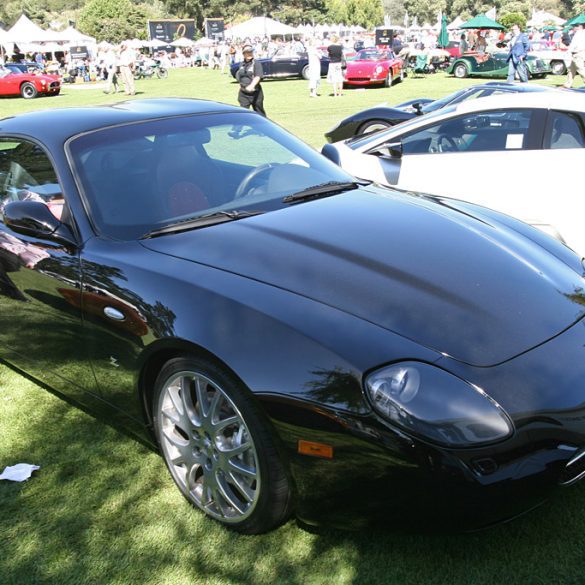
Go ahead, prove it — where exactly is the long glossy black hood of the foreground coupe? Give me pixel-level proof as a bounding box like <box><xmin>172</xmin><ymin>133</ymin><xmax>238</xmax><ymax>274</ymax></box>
<box><xmin>142</xmin><ymin>187</ymin><xmax>585</xmax><ymax>366</ymax></box>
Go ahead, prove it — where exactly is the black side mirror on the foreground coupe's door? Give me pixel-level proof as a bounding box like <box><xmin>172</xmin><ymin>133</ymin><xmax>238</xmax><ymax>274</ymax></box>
<box><xmin>4</xmin><ymin>201</ymin><xmax>77</xmax><ymax>246</ymax></box>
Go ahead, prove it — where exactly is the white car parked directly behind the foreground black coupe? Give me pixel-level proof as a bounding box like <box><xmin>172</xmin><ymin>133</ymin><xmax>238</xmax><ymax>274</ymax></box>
<box><xmin>322</xmin><ymin>90</ymin><xmax>585</xmax><ymax>256</ymax></box>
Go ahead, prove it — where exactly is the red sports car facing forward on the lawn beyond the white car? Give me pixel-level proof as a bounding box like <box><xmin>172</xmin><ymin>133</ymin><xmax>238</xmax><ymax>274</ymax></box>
<box><xmin>344</xmin><ymin>49</ymin><xmax>406</xmax><ymax>87</ymax></box>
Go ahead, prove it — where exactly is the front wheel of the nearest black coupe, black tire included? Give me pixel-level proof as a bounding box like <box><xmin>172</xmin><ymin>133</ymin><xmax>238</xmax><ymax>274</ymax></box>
<box><xmin>153</xmin><ymin>356</ymin><xmax>291</xmax><ymax>534</ymax></box>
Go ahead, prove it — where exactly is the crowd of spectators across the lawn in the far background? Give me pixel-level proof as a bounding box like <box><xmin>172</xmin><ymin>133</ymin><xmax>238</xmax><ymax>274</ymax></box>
<box><xmin>2</xmin><ymin>20</ymin><xmax>585</xmax><ymax>100</ymax></box>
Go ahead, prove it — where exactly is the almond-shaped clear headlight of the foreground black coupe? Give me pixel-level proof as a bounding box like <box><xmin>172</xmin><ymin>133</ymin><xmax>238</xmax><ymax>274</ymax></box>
<box><xmin>366</xmin><ymin>362</ymin><xmax>514</xmax><ymax>447</ymax></box>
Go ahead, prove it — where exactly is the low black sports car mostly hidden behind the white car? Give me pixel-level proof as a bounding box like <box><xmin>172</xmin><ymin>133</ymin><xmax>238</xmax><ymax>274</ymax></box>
<box><xmin>325</xmin><ymin>81</ymin><xmax>550</xmax><ymax>142</ymax></box>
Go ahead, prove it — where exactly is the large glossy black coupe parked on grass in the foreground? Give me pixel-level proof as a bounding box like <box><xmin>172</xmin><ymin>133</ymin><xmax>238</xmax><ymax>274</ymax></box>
<box><xmin>0</xmin><ymin>99</ymin><xmax>585</xmax><ymax>533</ymax></box>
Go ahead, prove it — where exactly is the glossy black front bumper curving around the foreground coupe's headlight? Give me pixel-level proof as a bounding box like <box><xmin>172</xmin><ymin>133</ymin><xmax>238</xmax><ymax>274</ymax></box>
<box><xmin>263</xmin><ymin>321</ymin><xmax>585</xmax><ymax>530</ymax></box>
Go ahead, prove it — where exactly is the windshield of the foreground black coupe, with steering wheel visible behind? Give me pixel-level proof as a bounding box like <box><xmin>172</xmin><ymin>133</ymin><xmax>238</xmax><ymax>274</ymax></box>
<box><xmin>67</xmin><ymin>112</ymin><xmax>353</xmax><ymax>240</ymax></box>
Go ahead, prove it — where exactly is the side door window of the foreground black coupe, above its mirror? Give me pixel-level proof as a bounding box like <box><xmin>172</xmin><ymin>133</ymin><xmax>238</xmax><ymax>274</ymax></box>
<box><xmin>0</xmin><ymin>139</ymin><xmax>63</xmax><ymax>220</ymax></box>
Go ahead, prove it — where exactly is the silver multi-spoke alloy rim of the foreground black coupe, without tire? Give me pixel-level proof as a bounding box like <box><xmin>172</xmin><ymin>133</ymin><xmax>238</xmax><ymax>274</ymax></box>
<box><xmin>157</xmin><ymin>371</ymin><xmax>261</xmax><ymax>523</ymax></box>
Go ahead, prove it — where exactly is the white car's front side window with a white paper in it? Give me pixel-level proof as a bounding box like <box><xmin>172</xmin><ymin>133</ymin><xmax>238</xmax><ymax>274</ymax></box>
<box><xmin>402</xmin><ymin>110</ymin><xmax>532</xmax><ymax>154</ymax></box>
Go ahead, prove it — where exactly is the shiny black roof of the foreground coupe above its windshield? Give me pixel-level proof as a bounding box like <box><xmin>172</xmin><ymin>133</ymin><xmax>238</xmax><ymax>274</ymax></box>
<box><xmin>0</xmin><ymin>98</ymin><xmax>244</xmax><ymax>143</ymax></box>
